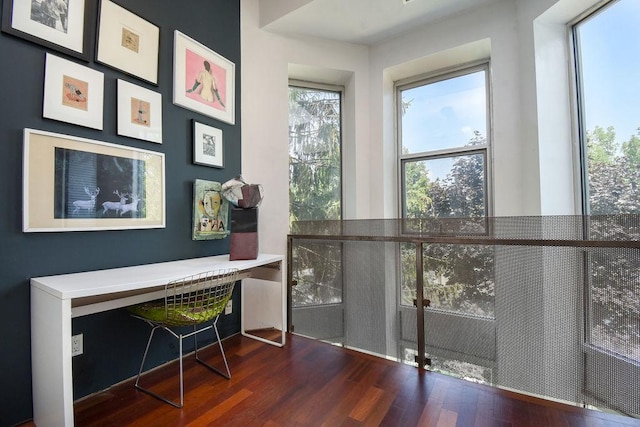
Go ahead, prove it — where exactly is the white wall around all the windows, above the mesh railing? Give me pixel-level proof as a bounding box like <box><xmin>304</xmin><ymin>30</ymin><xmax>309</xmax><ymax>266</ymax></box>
<box><xmin>241</xmin><ymin>0</ymin><xmax>596</xmax><ymax>253</ymax></box>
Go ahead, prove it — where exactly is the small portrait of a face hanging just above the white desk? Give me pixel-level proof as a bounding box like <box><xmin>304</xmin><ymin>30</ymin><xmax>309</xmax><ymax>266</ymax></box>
<box><xmin>192</xmin><ymin>179</ymin><xmax>229</xmax><ymax>240</ymax></box>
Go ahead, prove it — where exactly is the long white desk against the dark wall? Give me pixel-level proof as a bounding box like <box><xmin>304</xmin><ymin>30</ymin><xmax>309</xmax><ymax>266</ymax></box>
<box><xmin>31</xmin><ymin>254</ymin><xmax>287</xmax><ymax>427</ymax></box>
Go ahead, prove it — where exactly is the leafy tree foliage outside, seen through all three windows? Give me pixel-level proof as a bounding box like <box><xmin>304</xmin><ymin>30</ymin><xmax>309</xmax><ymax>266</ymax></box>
<box><xmin>289</xmin><ymin>87</ymin><xmax>640</xmax><ymax>360</ymax></box>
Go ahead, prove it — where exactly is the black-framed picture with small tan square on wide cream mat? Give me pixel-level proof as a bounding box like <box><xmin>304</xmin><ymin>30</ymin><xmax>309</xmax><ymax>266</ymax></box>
<box><xmin>96</xmin><ymin>0</ymin><xmax>160</xmax><ymax>85</ymax></box>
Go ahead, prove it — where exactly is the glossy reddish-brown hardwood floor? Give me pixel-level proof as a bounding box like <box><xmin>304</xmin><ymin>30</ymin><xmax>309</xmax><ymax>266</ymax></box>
<box><xmin>20</xmin><ymin>335</ymin><xmax>640</xmax><ymax>427</ymax></box>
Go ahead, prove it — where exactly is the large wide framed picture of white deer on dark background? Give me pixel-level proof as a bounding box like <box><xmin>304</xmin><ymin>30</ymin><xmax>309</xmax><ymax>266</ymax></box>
<box><xmin>22</xmin><ymin>129</ymin><xmax>165</xmax><ymax>233</ymax></box>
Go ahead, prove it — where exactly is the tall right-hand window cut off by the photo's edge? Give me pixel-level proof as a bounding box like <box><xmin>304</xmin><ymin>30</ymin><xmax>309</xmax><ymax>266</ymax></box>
<box><xmin>572</xmin><ymin>0</ymin><xmax>640</xmax><ymax>414</ymax></box>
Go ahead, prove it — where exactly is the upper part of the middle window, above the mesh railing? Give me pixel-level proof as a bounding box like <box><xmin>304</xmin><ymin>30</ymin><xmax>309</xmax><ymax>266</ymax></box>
<box><xmin>398</xmin><ymin>65</ymin><xmax>489</xmax><ymax>222</ymax></box>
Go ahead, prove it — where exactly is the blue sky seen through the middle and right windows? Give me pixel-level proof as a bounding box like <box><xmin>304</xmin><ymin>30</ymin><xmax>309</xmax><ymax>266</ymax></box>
<box><xmin>402</xmin><ymin>0</ymin><xmax>640</xmax><ymax>179</ymax></box>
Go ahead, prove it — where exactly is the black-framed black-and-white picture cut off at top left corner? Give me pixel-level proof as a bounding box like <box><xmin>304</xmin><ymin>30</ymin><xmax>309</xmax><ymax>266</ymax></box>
<box><xmin>1</xmin><ymin>0</ymin><xmax>97</xmax><ymax>62</ymax></box>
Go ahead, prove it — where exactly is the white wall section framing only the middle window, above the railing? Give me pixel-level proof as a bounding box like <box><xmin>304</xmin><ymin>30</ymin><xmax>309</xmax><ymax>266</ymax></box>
<box><xmin>371</xmin><ymin>0</ymin><xmax>526</xmax><ymax>216</ymax></box>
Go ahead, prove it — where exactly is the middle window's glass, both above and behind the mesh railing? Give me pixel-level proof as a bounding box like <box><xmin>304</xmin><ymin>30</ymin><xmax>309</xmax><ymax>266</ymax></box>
<box><xmin>397</xmin><ymin>64</ymin><xmax>494</xmax><ymax>318</ymax></box>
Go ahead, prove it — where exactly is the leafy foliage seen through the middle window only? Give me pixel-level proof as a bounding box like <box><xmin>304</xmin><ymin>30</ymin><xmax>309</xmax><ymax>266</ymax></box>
<box><xmin>400</xmin><ymin>131</ymin><xmax>494</xmax><ymax>317</ymax></box>
